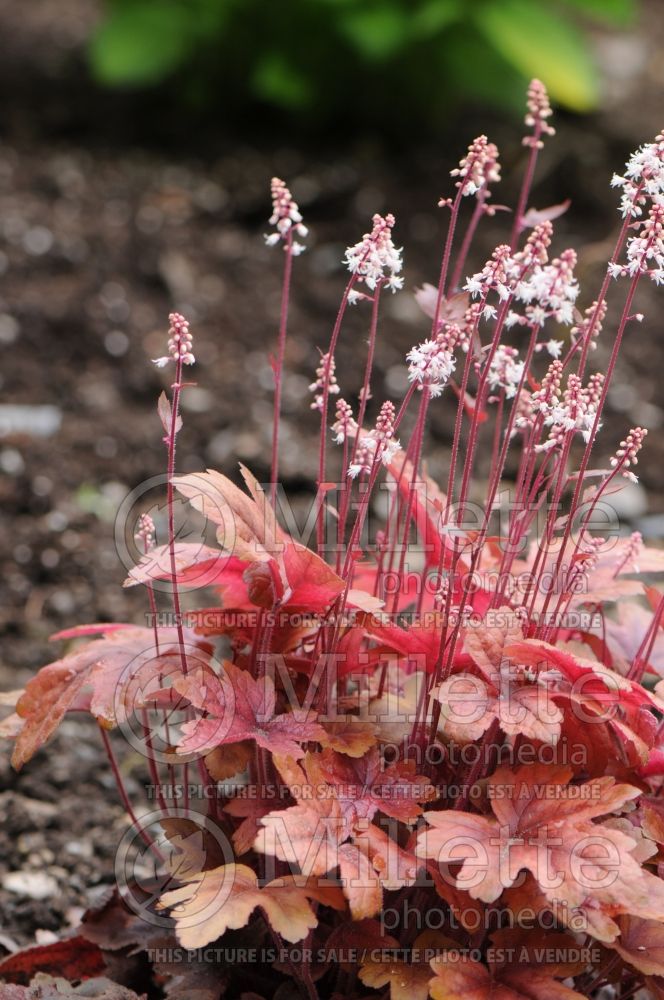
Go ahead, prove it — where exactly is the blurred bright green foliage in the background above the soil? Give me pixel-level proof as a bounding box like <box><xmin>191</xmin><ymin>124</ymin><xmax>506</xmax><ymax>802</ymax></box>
<box><xmin>90</xmin><ymin>0</ymin><xmax>637</xmax><ymax>122</ymax></box>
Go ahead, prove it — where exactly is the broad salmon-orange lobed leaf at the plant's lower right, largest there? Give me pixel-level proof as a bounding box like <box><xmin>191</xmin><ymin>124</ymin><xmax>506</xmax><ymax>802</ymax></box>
<box><xmin>418</xmin><ymin>765</ymin><xmax>664</xmax><ymax>941</ymax></box>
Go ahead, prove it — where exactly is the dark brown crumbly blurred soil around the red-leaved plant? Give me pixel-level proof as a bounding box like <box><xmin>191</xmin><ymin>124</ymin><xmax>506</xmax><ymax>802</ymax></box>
<box><xmin>0</xmin><ymin>0</ymin><xmax>664</xmax><ymax>984</ymax></box>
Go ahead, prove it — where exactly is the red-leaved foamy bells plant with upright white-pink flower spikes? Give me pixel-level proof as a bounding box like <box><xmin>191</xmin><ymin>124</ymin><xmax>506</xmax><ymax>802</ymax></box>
<box><xmin>5</xmin><ymin>81</ymin><xmax>664</xmax><ymax>1000</ymax></box>
